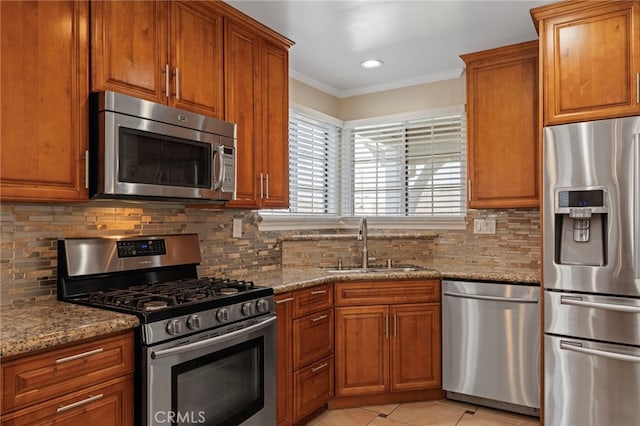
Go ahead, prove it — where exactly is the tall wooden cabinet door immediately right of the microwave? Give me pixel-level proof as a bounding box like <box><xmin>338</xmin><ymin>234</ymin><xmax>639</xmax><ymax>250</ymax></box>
<box><xmin>224</xmin><ymin>20</ymin><xmax>263</xmax><ymax>208</ymax></box>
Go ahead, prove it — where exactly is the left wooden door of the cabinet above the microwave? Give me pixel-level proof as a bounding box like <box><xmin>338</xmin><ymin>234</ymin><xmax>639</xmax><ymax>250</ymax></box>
<box><xmin>91</xmin><ymin>1</ymin><xmax>171</xmax><ymax>103</ymax></box>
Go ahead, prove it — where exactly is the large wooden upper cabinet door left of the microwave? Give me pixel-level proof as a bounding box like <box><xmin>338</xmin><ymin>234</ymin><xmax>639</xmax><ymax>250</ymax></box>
<box><xmin>0</xmin><ymin>1</ymin><xmax>89</xmax><ymax>201</ymax></box>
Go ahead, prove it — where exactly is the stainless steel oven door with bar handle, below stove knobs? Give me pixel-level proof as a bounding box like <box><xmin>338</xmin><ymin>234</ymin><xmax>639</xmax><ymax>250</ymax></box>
<box><xmin>142</xmin><ymin>316</ymin><xmax>276</xmax><ymax>426</ymax></box>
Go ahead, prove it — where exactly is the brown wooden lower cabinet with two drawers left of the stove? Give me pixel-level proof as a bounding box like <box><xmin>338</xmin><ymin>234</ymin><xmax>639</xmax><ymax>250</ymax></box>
<box><xmin>0</xmin><ymin>331</ymin><xmax>134</xmax><ymax>426</ymax></box>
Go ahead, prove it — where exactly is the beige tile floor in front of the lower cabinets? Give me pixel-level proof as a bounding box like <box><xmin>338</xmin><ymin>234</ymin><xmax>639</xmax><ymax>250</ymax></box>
<box><xmin>308</xmin><ymin>400</ymin><xmax>540</xmax><ymax>426</ymax></box>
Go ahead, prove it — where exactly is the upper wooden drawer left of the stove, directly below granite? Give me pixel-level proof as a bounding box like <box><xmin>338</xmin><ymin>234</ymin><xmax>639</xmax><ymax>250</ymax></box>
<box><xmin>2</xmin><ymin>332</ymin><xmax>134</xmax><ymax>412</ymax></box>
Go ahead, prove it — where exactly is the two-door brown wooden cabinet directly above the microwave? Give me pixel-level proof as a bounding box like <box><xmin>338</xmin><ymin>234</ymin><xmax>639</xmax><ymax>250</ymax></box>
<box><xmin>91</xmin><ymin>1</ymin><xmax>224</xmax><ymax>118</ymax></box>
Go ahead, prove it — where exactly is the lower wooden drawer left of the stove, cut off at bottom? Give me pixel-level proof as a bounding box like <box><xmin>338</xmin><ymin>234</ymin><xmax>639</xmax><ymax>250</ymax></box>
<box><xmin>2</xmin><ymin>375</ymin><xmax>133</xmax><ymax>426</ymax></box>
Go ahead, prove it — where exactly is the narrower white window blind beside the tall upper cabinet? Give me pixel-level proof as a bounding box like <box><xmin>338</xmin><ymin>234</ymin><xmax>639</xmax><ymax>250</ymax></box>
<box><xmin>288</xmin><ymin>110</ymin><xmax>341</xmax><ymax>215</ymax></box>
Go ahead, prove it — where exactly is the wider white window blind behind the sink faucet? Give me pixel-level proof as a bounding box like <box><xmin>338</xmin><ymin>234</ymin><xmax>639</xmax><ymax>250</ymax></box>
<box><xmin>347</xmin><ymin>114</ymin><xmax>466</xmax><ymax>217</ymax></box>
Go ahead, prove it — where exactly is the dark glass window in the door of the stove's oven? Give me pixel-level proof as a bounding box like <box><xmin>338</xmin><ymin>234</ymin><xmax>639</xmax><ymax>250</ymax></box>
<box><xmin>171</xmin><ymin>337</ymin><xmax>264</xmax><ymax>425</ymax></box>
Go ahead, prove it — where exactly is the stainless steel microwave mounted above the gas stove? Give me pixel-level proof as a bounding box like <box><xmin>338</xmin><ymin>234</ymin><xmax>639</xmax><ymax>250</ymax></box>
<box><xmin>88</xmin><ymin>91</ymin><xmax>236</xmax><ymax>202</ymax></box>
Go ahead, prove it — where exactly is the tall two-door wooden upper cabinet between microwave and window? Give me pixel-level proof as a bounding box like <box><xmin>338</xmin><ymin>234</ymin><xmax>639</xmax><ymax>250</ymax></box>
<box><xmin>224</xmin><ymin>18</ymin><xmax>293</xmax><ymax>208</ymax></box>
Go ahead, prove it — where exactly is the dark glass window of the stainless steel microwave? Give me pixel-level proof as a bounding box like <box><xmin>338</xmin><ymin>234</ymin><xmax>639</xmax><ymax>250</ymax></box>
<box><xmin>118</xmin><ymin>127</ymin><xmax>212</xmax><ymax>188</ymax></box>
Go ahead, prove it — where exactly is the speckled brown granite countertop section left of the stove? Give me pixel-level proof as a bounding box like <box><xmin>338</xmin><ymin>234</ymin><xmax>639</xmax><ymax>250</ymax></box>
<box><xmin>0</xmin><ymin>300</ymin><xmax>139</xmax><ymax>358</ymax></box>
